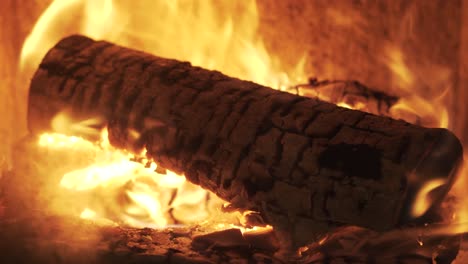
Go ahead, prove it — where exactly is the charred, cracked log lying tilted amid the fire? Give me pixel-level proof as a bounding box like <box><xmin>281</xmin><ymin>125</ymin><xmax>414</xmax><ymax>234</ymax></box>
<box><xmin>28</xmin><ymin>36</ymin><xmax>462</xmax><ymax>248</ymax></box>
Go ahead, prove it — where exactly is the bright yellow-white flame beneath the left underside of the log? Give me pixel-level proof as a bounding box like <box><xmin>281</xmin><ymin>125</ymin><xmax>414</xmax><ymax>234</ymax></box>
<box><xmin>38</xmin><ymin>129</ymin><xmax>233</xmax><ymax>227</ymax></box>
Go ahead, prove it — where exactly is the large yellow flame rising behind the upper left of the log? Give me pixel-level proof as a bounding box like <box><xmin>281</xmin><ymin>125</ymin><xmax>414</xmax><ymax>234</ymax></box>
<box><xmin>20</xmin><ymin>0</ymin><xmax>306</xmax><ymax>89</ymax></box>
